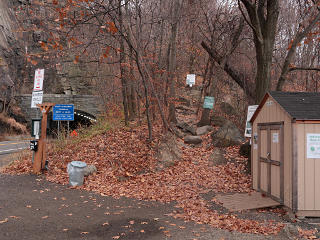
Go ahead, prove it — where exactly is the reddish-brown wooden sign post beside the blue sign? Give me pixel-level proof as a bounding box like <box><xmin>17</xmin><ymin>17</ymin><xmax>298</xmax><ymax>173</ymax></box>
<box><xmin>33</xmin><ymin>103</ymin><xmax>55</xmax><ymax>174</ymax></box>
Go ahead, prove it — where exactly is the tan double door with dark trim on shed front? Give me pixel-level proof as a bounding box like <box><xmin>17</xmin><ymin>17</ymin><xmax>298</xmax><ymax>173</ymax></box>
<box><xmin>258</xmin><ymin>123</ymin><xmax>283</xmax><ymax>202</ymax></box>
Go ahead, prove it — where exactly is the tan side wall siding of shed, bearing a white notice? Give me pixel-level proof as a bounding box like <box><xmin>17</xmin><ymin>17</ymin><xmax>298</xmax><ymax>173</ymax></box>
<box><xmin>297</xmin><ymin>124</ymin><xmax>320</xmax><ymax>210</ymax></box>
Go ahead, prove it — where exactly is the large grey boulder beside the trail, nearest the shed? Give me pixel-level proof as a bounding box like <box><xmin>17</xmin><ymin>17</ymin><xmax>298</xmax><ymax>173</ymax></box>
<box><xmin>211</xmin><ymin>121</ymin><xmax>244</xmax><ymax>147</ymax></box>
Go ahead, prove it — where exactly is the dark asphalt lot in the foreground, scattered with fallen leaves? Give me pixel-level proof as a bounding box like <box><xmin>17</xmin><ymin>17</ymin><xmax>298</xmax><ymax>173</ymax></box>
<box><xmin>0</xmin><ymin>174</ymin><xmax>288</xmax><ymax>240</ymax></box>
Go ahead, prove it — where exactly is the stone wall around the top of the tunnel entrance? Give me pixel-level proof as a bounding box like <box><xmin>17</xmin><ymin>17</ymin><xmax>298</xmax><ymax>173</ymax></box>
<box><xmin>15</xmin><ymin>94</ymin><xmax>103</xmax><ymax>120</ymax></box>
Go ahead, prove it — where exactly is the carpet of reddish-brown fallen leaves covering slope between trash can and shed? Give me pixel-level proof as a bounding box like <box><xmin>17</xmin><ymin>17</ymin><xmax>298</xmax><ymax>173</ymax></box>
<box><xmin>1</xmin><ymin>123</ymin><xmax>283</xmax><ymax>235</ymax></box>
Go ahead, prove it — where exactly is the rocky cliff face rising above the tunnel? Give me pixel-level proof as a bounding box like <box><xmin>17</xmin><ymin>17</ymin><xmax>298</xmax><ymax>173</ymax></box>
<box><xmin>0</xmin><ymin>0</ymin><xmax>97</xmax><ymax>103</ymax></box>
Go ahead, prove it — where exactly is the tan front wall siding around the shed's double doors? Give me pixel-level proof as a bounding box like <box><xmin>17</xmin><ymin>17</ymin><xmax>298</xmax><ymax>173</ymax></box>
<box><xmin>252</xmin><ymin>96</ymin><xmax>292</xmax><ymax>208</ymax></box>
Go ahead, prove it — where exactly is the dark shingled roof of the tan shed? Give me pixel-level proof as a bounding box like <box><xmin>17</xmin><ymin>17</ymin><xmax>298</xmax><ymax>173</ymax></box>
<box><xmin>251</xmin><ymin>91</ymin><xmax>320</xmax><ymax>122</ymax></box>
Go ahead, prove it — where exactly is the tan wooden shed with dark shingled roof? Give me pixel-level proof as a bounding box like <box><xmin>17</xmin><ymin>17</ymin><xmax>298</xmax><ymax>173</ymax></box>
<box><xmin>251</xmin><ymin>92</ymin><xmax>320</xmax><ymax>217</ymax></box>
